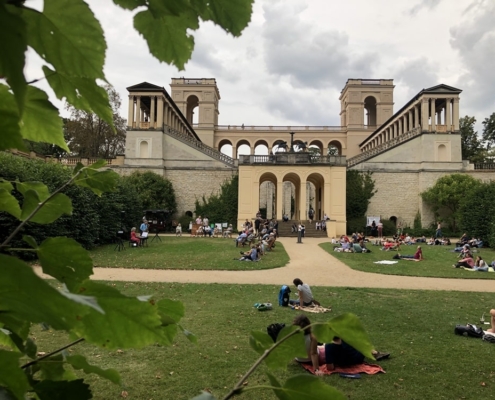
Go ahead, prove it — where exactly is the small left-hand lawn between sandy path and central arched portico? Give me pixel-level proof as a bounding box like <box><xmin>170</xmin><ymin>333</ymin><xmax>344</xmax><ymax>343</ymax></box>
<box><xmin>90</xmin><ymin>236</ymin><xmax>289</xmax><ymax>271</ymax></box>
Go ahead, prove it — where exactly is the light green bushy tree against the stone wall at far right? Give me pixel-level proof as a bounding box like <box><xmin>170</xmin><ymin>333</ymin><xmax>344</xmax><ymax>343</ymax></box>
<box><xmin>421</xmin><ymin>174</ymin><xmax>481</xmax><ymax>231</ymax></box>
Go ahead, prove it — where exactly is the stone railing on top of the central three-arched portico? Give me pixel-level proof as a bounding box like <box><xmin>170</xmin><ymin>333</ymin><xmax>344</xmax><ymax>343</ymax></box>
<box><xmin>239</xmin><ymin>152</ymin><xmax>346</xmax><ymax>167</ymax></box>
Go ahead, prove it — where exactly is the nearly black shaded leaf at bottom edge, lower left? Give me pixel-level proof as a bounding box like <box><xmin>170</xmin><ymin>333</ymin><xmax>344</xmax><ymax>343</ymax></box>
<box><xmin>33</xmin><ymin>379</ymin><xmax>93</xmax><ymax>400</ymax></box>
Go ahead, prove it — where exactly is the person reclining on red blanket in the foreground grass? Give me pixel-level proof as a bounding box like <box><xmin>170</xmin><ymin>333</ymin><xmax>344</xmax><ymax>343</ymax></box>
<box><xmin>292</xmin><ymin>314</ymin><xmax>390</xmax><ymax>375</ymax></box>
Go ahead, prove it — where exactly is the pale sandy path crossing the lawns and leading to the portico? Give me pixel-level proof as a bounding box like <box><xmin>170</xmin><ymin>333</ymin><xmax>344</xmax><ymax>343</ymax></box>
<box><xmin>36</xmin><ymin>237</ymin><xmax>495</xmax><ymax>292</ymax></box>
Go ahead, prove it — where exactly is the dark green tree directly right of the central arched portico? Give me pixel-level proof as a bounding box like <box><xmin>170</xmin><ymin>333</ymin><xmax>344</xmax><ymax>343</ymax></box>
<box><xmin>346</xmin><ymin>170</ymin><xmax>376</xmax><ymax>220</ymax></box>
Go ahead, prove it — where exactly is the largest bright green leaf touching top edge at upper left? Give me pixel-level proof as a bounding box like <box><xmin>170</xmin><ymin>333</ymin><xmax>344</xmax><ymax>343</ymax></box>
<box><xmin>24</xmin><ymin>0</ymin><xmax>106</xmax><ymax>80</ymax></box>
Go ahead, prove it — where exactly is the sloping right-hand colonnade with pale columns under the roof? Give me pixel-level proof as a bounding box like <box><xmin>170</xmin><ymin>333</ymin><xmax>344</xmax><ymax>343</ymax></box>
<box><xmin>361</xmin><ymin>96</ymin><xmax>459</xmax><ymax>152</ymax></box>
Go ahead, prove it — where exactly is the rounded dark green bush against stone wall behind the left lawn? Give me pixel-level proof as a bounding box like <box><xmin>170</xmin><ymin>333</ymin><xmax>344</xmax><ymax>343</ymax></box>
<box><xmin>124</xmin><ymin>171</ymin><xmax>177</xmax><ymax>213</ymax></box>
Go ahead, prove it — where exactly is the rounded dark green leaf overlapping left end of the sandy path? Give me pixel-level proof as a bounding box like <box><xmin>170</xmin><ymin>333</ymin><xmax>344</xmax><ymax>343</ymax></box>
<box><xmin>37</xmin><ymin>237</ymin><xmax>93</xmax><ymax>289</ymax></box>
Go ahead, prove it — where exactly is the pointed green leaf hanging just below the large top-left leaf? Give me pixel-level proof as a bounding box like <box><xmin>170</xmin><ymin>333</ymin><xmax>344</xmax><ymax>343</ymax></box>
<box><xmin>43</xmin><ymin>66</ymin><xmax>113</xmax><ymax>126</ymax></box>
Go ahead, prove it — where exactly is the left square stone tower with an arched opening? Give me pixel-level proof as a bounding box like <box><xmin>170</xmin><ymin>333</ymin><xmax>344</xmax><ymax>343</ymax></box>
<box><xmin>170</xmin><ymin>78</ymin><xmax>220</xmax><ymax>147</ymax></box>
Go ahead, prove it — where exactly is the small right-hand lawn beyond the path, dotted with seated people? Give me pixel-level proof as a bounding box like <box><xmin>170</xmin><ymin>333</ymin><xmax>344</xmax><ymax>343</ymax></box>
<box><xmin>320</xmin><ymin>242</ymin><xmax>495</xmax><ymax>279</ymax></box>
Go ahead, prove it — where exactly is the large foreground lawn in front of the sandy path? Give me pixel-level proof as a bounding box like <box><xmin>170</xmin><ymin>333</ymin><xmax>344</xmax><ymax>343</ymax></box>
<box><xmin>29</xmin><ymin>278</ymin><xmax>495</xmax><ymax>400</ymax></box>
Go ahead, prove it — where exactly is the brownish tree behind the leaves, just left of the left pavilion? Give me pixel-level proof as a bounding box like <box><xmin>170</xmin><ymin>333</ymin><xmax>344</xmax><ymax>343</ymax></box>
<box><xmin>66</xmin><ymin>85</ymin><xmax>126</xmax><ymax>158</ymax></box>
